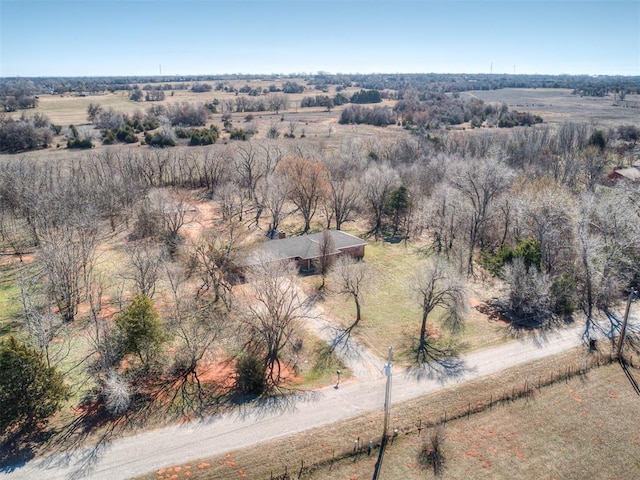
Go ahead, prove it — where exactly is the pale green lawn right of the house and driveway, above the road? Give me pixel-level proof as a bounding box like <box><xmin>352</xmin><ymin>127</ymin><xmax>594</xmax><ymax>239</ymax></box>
<box><xmin>312</xmin><ymin>241</ymin><xmax>508</xmax><ymax>361</ymax></box>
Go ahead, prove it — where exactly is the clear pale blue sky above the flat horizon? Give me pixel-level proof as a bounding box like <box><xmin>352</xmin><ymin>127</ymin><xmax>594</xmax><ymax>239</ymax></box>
<box><xmin>0</xmin><ymin>0</ymin><xmax>640</xmax><ymax>76</ymax></box>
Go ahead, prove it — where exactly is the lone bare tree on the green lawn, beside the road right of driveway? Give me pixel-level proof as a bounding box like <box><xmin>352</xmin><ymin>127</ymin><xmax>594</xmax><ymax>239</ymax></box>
<box><xmin>411</xmin><ymin>256</ymin><xmax>467</xmax><ymax>363</ymax></box>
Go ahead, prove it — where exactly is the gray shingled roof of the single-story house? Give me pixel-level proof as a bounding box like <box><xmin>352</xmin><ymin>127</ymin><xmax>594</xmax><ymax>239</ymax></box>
<box><xmin>239</xmin><ymin>230</ymin><xmax>367</xmax><ymax>267</ymax></box>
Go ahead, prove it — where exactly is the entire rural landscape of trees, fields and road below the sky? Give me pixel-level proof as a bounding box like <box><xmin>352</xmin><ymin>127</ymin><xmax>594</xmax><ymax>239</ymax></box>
<box><xmin>0</xmin><ymin>72</ymin><xmax>640</xmax><ymax>480</ymax></box>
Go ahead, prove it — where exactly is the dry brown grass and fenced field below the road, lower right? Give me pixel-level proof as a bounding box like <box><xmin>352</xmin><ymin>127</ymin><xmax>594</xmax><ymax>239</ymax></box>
<box><xmin>138</xmin><ymin>349</ymin><xmax>640</xmax><ymax>480</ymax></box>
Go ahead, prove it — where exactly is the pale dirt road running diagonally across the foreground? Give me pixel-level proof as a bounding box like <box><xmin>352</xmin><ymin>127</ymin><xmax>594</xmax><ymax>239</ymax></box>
<box><xmin>0</xmin><ymin>326</ymin><xmax>596</xmax><ymax>480</ymax></box>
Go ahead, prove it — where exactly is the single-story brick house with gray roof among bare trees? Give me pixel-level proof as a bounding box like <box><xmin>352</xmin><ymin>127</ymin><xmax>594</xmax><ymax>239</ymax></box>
<box><xmin>238</xmin><ymin>230</ymin><xmax>367</xmax><ymax>271</ymax></box>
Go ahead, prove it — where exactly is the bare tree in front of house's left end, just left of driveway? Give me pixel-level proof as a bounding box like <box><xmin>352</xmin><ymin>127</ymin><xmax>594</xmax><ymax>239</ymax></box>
<box><xmin>244</xmin><ymin>257</ymin><xmax>305</xmax><ymax>388</ymax></box>
